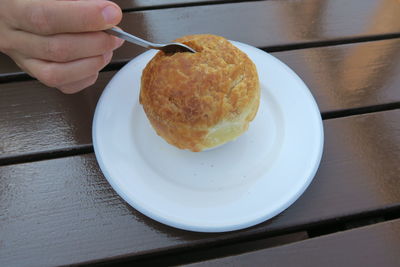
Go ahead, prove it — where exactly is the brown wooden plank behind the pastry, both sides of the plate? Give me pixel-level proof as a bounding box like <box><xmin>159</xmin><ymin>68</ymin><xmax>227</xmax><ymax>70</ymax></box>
<box><xmin>0</xmin><ymin>39</ymin><xmax>400</xmax><ymax>162</ymax></box>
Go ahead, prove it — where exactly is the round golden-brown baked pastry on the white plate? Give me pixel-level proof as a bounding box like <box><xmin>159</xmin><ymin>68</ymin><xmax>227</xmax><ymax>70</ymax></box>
<box><xmin>140</xmin><ymin>34</ymin><xmax>260</xmax><ymax>152</ymax></box>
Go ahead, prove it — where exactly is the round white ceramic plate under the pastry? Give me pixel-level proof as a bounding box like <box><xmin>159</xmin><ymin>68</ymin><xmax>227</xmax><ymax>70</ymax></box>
<box><xmin>93</xmin><ymin>42</ymin><xmax>323</xmax><ymax>232</ymax></box>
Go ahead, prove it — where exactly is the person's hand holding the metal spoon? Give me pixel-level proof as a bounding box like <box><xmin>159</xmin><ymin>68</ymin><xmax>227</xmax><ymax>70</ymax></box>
<box><xmin>0</xmin><ymin>0</ymin><xmax>123</xmax><ymax>93</ymax></box>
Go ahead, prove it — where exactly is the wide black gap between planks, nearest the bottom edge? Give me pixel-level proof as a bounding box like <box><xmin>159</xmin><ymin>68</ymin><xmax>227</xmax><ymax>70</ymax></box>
<box><xmin>79</xmin><ymin>208</ymin><xmax>400</xmax><ymax>267</ymax></box>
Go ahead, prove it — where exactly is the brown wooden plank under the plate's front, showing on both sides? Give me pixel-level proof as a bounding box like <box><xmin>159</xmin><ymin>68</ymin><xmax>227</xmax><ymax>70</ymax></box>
<box><xmin>0</xmin><ymin>110</ymin><xmax>400</xmax><ymax>266</ymax></box>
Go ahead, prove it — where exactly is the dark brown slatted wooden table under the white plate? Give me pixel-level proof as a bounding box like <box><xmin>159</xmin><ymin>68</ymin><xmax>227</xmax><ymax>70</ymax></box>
<box><xmin>0</xmin><ymin>0</ymin><xmax>400</xmax><ymax>266</ymax></box>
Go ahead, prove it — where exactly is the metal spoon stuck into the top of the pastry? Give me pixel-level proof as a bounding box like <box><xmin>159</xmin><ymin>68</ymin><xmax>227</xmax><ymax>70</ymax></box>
<box><xmin>104</xmin><ymin>27</ymin><xmax>196</xmax><ymax>53</ymax></box>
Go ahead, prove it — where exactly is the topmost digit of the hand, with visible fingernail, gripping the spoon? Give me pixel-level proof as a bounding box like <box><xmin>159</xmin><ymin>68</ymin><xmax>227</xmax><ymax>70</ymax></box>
<box><xmin>13</xmin><ymin>0</ymin><xmax>122</xmax><ymax>35</ymax></box>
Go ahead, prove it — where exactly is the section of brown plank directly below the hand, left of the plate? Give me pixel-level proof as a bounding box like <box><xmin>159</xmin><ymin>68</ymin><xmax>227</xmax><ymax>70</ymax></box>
<box><xmin>0</xmin><ymin>72</ymin><xmax>114</xmax><ymax>162</ymax></box>
